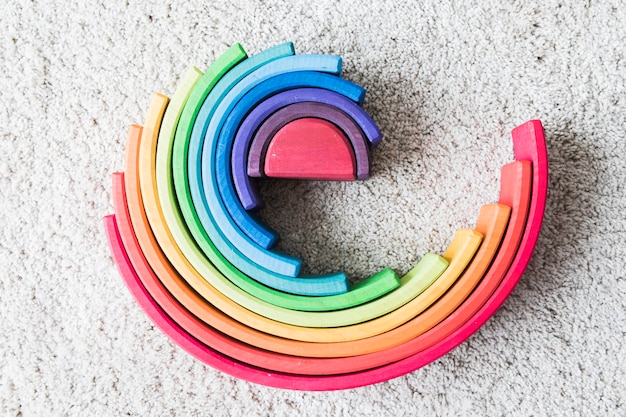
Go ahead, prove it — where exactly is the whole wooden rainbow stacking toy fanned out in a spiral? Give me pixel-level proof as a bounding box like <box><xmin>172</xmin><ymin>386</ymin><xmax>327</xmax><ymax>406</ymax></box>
<box><xmin>104</xmin><ymin>43</ymin><xmax>548</xmax><ymax>390</ymax></box>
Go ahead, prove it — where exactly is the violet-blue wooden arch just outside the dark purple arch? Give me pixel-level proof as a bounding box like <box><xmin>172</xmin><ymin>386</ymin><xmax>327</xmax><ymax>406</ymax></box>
<box><xmin>229</xmin><ymin>88</ymin><xmax>382</xmax><ymax>210</ymax></box>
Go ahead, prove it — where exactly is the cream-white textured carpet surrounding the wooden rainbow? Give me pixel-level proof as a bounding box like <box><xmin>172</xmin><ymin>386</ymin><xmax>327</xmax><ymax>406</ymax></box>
<box><xmin>0</xmin><ymin>0</ymin><xmax>626</xmax><ymax>417</ymax></box>
